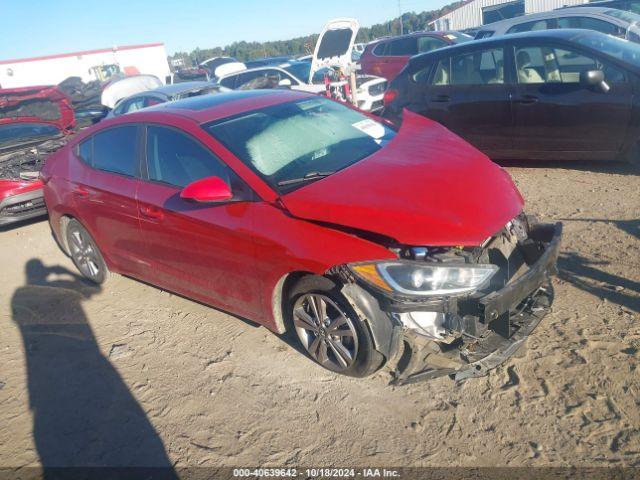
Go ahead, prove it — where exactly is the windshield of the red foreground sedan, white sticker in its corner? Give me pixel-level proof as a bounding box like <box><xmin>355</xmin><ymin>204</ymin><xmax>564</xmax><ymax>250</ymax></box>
<box><xmin>204</xmin><ymin>98</ymin><xmax>395</xmax><ymax>192</ymax></box>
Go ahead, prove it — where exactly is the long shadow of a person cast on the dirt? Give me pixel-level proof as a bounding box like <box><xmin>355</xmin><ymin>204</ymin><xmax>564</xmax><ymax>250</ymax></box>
<box><xmin>11</xmin><ymin>259</ymin><xmax>178</xmax><ymax>478</ymax></box>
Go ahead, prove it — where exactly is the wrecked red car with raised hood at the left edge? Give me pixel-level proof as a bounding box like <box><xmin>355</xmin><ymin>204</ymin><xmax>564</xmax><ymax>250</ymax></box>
<box><xmin>0</xmin><ymin>86</ymin><xmax>75</xmax><ymax>226</ymax></box>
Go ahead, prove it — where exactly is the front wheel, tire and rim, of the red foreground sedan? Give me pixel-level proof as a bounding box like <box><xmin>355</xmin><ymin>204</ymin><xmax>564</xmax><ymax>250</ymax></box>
<box><xmin>285</xmin><ymin>277</ymin><xmax>384</xmax><ymax>377</ymax></box>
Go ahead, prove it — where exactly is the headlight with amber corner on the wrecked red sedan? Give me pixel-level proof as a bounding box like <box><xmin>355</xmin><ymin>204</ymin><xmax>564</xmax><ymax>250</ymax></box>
<box><xmin>350</xmin><ymin>261</ymin><xmax>498</xmax><ymax>297</ymax></box>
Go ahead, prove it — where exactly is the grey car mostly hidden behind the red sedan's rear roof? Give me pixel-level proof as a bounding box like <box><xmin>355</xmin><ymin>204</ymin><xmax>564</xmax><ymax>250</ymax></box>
<box><xmin>107</xmin><ymin>82</ymin><xmax>228</xmax><ymax>118</ymax></box>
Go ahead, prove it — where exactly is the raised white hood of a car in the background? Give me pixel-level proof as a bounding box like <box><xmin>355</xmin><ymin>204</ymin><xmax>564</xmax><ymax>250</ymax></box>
<box><xmin>306</xmin><ymin>18</ymin><xmax>360</xmax><ymax>83</ymax></box>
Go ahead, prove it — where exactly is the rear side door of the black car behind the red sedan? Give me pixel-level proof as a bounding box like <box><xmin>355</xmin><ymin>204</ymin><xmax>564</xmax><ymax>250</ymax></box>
<box><xmin>416</xmin><ymin>46</ymin><xmax>513</xmax><ymax>156</ymax></box>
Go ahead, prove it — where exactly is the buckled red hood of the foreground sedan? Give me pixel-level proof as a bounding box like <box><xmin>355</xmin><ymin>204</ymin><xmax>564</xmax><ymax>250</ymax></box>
<box><xmin>281</xmin><ymin>110</ymin><xmax>523</xmax><ymax>246</ymax></box>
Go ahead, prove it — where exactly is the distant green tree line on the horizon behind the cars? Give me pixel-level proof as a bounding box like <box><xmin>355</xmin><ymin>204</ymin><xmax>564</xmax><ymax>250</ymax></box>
<box><xmin>169</xmin><ymin>0</ymin><xmax>465</xmax><ymax>66</ymax></box>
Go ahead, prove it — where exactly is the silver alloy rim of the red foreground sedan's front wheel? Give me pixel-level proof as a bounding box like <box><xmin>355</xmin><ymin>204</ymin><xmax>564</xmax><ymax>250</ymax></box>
<box><xmin>293</xmin><ymin>293</ymin><xmax>358</xmax><ymax>372</ymax></box>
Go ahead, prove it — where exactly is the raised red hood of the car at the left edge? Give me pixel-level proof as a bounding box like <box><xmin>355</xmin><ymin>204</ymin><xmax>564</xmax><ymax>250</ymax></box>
<box><xmin>0</xmin><ymin>86</ymin><xmax>75</xmax><ymax>132</ymax></box>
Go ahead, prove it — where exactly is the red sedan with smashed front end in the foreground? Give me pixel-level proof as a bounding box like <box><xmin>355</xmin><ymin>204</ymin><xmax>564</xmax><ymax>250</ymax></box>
<box><xmin>42</xmin><ymin>90</ymin><xmax>560</xmax><ymax>383</ymax></box>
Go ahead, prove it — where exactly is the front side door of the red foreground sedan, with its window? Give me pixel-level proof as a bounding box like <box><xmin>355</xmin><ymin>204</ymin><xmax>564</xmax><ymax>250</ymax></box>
<box><xmin>137</xmin><ymin>125</ymin><xmax>260</xmax><ymax>316</ymax></box>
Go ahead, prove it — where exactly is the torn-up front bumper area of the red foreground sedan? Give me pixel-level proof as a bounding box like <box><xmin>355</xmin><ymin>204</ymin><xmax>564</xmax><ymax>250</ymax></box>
<box><xmin>345</xmin><ymin>223</ymin><xmax>562</xmax><ymax>385</ymax></box>
